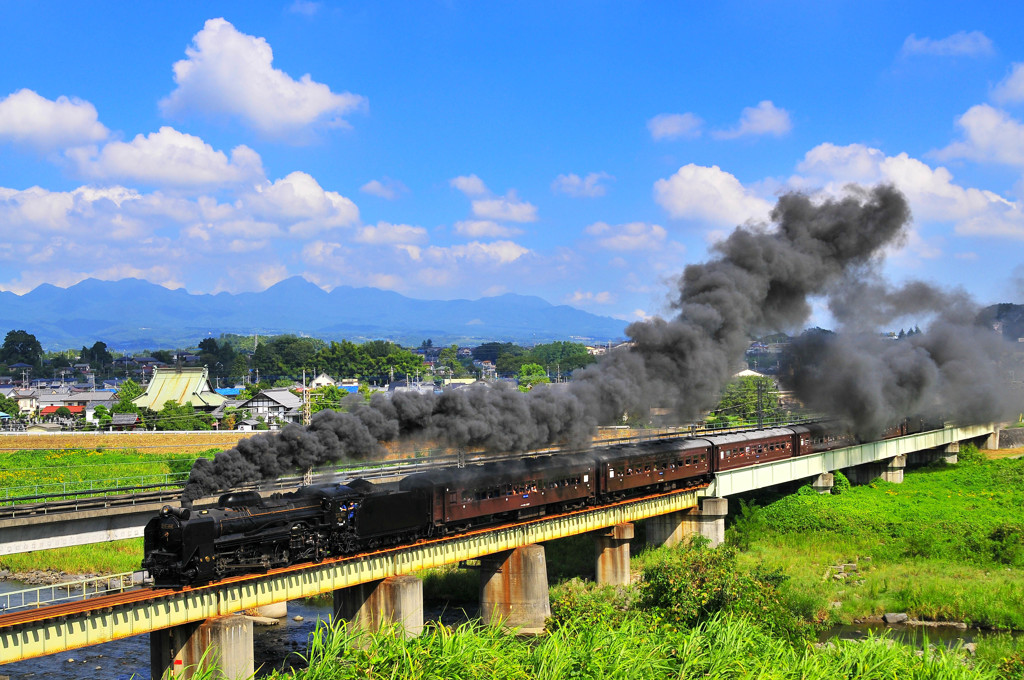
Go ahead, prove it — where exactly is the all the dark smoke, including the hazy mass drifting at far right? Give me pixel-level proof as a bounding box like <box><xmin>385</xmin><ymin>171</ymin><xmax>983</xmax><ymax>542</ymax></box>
<box><xmin>184</xmin><ymin>185</ymin><xmax>1005</xmax><ymax>499</ymax></box>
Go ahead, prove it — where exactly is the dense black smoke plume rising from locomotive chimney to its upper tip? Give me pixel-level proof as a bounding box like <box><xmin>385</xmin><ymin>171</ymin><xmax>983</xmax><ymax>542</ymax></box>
<box><xmin>184</xmin><ymin>185</ymin><xmax>1015</xmax><ymax>499</ymax></box>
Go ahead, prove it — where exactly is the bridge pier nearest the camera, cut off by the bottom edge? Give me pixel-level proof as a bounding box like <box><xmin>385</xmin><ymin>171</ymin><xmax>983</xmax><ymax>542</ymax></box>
<box><xmin>150</xmin><ymin>615</ymin><xmax>255</xmax><ymax>680</ymax></box>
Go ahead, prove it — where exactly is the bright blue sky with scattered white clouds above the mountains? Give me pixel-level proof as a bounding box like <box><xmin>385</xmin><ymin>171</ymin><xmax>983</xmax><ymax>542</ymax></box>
<box><xmin>0</xmin><ymin>0</ymin><xmax>1024</xmax><ymax>329</ymax></box>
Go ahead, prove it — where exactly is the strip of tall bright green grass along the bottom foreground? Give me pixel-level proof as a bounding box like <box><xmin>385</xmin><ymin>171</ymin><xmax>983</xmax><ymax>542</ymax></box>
<box><xmin>262</xmin><ymin>614</ymin><xmax>1000</xmax><ymax>680</ymax></box>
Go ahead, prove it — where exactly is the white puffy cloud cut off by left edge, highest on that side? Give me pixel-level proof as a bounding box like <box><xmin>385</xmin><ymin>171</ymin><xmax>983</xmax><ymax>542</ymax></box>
<box><xmin>0</xmin><ymin>89</ymin><xmax>109</xmax><ymax>151</ymax></box>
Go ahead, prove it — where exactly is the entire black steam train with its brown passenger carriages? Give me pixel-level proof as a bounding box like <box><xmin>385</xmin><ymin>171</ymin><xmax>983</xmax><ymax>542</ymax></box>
<box><xmin>142</xmin><ymin>422</ymin><xmax>929</xmax><ymax>587</ymax></box>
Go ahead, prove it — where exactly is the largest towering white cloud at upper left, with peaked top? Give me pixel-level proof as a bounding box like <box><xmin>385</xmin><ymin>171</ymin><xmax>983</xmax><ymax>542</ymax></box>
<box><xmin>160</xmin><ymin>18</ymin><xmax>367</xmax><ymax>135</ymax></box>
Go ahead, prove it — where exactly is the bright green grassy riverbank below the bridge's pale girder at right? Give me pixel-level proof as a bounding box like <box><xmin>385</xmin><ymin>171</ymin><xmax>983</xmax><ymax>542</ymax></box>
<box><xmin>729</xmin><ymin>448</ymin><xmax>1024</xmax><ymax>630</ymax></box>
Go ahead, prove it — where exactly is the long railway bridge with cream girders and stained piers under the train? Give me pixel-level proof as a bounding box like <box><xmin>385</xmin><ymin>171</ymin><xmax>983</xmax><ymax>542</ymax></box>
<box><xmin>0</xmin><ymin>426</ymin><xmax>997</xmax><ymax>678</ymax></box>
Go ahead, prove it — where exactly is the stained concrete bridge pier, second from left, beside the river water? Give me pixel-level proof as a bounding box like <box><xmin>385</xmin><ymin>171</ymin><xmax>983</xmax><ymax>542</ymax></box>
<box><xmin>334</xmin><ymin>573</ymin><xmax>423</xmax><ymax>639</ymax></box>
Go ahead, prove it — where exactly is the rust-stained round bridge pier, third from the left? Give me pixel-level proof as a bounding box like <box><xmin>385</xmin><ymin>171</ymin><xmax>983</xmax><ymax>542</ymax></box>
<box><xmin>480</xmin><ymin>544</ymin><xmax>551</xmax><ymax>634</ymax></box>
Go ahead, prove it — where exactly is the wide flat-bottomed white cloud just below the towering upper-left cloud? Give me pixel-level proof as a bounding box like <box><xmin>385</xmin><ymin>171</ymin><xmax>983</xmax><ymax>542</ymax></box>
<box><xmin>68</xmin><ymin>127</ymin><xmax>263</xmax><ymax>187</ymax></box>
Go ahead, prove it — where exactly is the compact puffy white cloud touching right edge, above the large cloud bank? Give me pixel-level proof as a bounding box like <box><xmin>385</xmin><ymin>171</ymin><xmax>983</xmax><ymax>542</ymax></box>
<box><xmin>935</xmin><ymin>103</ymin><xmax>1024</xmax><ymax>167</ymax></box>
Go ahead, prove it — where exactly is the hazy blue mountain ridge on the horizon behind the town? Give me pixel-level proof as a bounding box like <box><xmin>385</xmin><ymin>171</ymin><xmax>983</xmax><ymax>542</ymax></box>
<box><xmin>0</xmin><ymin>277</ymin><xmax>626</xmax><ymax>351</ymax></box>
